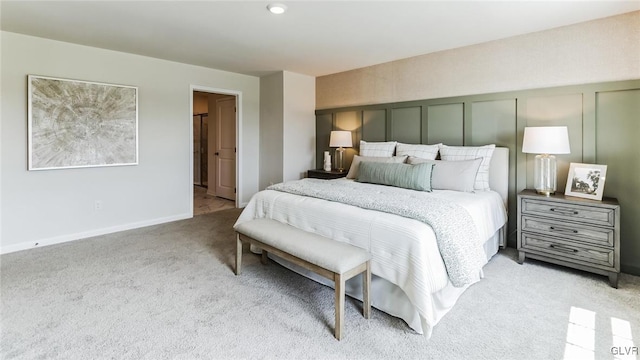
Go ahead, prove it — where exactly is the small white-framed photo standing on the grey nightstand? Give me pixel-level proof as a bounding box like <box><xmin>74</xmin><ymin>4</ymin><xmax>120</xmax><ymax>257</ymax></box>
<box><xmin>564</xmin><ymin>163</ymin><xmax>607</xmax><ymax>201</ymax></box>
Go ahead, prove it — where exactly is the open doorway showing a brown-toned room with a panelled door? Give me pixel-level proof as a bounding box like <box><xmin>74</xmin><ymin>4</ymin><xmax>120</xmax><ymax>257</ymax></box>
<box><xmin>192</xmin><ymin>89</ymin><xmax>238</xmax><ymax>216</ymax></box>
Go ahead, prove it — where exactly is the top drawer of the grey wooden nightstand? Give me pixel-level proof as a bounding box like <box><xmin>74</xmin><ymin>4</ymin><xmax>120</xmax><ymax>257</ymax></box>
<box><xmin>522</xmin><ymin>199</ymin><xmax>615</xmax><ymax>226</ymax></box>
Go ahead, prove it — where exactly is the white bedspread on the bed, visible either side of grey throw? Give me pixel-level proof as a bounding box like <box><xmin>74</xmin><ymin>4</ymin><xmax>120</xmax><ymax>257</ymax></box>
<box><xmin>232</xmin><ymin>179</ymin><xmax>507</xmax><ymax>333</ymax></box>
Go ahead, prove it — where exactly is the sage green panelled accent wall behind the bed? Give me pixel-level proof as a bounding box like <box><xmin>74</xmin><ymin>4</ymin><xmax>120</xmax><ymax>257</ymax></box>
<box><xmin>316</xmin><ymin>80</ymin><xmax>640</xmax><ymax>275</ymax></box>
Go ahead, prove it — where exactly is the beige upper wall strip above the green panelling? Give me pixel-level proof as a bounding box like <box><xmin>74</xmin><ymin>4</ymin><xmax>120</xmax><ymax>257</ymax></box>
<box><xmin>316</xmin><ymin>11</ymin><xmax>640</xmax><ymax>109</ymax></box>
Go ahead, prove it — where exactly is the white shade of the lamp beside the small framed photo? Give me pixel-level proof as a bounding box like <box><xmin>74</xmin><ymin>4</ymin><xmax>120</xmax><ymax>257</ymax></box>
<box><xmin>522</xmin><ymin>126</ymin><xmax>571</xmax><ymax>154</ymax></box>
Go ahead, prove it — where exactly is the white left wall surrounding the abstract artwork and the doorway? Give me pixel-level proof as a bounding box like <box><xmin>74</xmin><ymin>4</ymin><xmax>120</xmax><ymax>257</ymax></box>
<box><xmin>0</xmin><ymin>32</ymin><xmax>260</xmax><ymax>252</ymax></box>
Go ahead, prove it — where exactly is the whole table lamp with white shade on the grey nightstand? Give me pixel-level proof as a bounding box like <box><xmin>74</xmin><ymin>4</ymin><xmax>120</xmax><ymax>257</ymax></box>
<box><xmin>522</xmin><ymin>126</ymin><xmax>571</xmax><ymax>196</ymax></box>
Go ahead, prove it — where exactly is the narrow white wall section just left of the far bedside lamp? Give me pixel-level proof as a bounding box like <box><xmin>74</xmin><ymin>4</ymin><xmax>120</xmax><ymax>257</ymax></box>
<box><xmin>282</xmin><ymin>71</ymin><xmax>316</xmax><ymax>181</ymax></box>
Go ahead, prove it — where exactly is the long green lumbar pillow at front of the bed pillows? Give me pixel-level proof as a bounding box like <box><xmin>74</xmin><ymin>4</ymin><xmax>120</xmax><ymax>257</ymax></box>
<box><xmin>356</xmin><ymin>161</ymin><xmax>433</xmax><ymax>191</ymax></box>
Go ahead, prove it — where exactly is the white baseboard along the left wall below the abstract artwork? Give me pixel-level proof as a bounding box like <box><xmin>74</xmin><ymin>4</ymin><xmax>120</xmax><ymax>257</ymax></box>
<box><xmin>0</xmin><ymin>214</ymin><xmax>193</xmax><ymax>254</ymax></box>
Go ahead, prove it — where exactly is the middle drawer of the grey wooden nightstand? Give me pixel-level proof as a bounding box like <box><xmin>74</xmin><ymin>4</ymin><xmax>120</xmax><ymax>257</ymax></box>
<box><xmin>521</xmin><ymin>216</ymin><xmax>615</xmax><ymax>247</ymax></box>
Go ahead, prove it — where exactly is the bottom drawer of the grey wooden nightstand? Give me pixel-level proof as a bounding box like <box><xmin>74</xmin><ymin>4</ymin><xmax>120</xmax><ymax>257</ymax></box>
<box><xmin>522</xmin><ymin>233</ymin><xmax>614</xmax><ymax>268</ymax></box>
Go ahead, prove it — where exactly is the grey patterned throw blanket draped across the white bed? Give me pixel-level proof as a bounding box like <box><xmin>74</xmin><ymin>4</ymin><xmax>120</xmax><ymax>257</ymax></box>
<box><xmin>267</xmin><ymin>179</ymin><xmax>486</xmax><ymax>287</ymax></box>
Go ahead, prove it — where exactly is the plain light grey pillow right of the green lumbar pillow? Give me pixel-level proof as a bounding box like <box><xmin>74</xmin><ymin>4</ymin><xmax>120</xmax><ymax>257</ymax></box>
<box><xmin>407</xmin><ymin>156</ymin><xmax>482</xmax><ymax>192</ymax></box>
